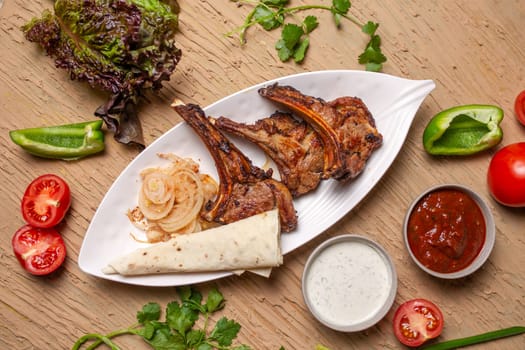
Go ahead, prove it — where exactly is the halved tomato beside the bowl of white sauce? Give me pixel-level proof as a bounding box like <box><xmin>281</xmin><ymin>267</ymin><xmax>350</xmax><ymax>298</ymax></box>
<box><xmin>394</xmin><ymin>299</ymin><xmax>444</xmax><ymax>347</ymax></box>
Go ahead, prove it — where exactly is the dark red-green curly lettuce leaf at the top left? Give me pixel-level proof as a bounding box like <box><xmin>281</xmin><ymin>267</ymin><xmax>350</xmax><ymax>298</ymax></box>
<box><xmin>22</xmin><ymin>0</ymin><xmax>181</xmax><ymax>148</ymax></box>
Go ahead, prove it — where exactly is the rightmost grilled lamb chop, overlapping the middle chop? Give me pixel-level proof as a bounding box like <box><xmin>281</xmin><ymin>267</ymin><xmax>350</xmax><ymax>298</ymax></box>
<box><xmin>259</xmin><ymin>84</ymin><xmax>383</xmax><ymax>181</ymax></box>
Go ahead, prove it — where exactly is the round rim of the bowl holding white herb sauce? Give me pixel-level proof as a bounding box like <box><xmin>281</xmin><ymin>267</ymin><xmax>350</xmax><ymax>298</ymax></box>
<box><xmin>301</xmin><ymin>233</ymin><xmax>398</xmax><ymax>332</ymax></box>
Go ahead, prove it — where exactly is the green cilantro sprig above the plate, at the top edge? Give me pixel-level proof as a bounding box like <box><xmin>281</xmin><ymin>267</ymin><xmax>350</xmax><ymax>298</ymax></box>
<box><xmin>226</xmin><ymin>0</ymin><xmax>387</xmax><ymax>72</ymax></box>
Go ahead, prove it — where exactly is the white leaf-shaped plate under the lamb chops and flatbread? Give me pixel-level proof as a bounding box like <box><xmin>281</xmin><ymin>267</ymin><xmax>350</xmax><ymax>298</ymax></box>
<box><xmin>78</xmin><ymin>70</ymin><xmax>435</xmax><ymax>286</ymax></box>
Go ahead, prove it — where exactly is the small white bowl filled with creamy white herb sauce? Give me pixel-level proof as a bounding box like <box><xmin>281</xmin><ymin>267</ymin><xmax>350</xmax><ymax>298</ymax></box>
<box><xmin>302</xmin><ymin>234</ymin><xmax>397</xmax><ymax>332</ymax></box>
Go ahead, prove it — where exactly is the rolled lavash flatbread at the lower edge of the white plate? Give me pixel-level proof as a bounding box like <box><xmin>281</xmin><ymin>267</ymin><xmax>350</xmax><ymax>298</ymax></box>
<box><xmin>102</xmin><ymin>209</ymin><xmax>283</xmax><ymax>276</ymax></box>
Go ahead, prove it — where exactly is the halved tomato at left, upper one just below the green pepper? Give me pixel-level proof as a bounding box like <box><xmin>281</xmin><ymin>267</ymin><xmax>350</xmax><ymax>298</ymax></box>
<box><xmin>22</xmin><ymin>174</ymin><xmax>71</xmax><ymax>228</ymax></box>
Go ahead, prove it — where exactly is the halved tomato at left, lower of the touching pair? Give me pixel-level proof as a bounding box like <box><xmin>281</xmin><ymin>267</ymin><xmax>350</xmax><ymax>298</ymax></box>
<box><xmin>11</xmin><ymin>225</ymin><xmax>66</xmax><ymax>275</ymax></box>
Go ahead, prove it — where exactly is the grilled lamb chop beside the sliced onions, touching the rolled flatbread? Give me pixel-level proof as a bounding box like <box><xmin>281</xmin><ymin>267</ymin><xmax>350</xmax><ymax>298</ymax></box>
<box><xmin>172</xmin><ymin>104</ymin><xmax>297</xmax><ymax>232</ymax></box>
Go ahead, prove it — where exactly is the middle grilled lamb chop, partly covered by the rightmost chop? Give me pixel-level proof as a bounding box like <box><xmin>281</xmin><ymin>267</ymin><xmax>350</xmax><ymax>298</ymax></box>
<box><xmin>211</xmin><ymin>112</ymin><xmax>324</xmax><ymax>197</ymax></box>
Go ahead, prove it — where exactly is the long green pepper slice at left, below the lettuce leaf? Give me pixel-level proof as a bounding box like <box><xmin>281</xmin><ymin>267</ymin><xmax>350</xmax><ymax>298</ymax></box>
<box><xmin>9</xmin><ymin>119</ymin><xmax>104</xmax><ymax>160</ymax></box>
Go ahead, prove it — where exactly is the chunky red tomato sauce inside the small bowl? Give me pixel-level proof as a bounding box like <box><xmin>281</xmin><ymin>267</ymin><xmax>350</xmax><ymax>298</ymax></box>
<box><xmin>407</xmin><ymin>189</ymin><xmax>486</xmax><ymax>273</ymax></box>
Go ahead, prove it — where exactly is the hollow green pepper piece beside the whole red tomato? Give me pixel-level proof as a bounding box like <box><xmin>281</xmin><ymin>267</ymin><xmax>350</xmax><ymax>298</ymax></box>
<box><xmin>423</xmin><ymin>105</ymin><xmax>503</xmax><ymax>155</ymax></box>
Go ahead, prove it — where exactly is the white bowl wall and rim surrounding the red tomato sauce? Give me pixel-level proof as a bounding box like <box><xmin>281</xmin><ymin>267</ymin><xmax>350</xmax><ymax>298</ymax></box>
<box><xmin>403</xmin><ymin>184</ymin><xmax>496</xmax><ymax>279</ymax></box>
